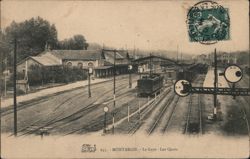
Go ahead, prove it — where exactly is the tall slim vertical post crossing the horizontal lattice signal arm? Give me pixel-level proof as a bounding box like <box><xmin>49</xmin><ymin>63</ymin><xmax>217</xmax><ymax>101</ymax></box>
<box><xmin>213</xmin><ymin>48</ymin><xmax>218</xmax><ymax>120</ymax></box>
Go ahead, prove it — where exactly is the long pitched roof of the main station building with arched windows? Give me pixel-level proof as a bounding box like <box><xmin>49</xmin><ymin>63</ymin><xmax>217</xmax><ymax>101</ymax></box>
<box><xmin>47</xmin><ymin>50</ymin><xmax>102</xmax><ymax>60</ymax></box>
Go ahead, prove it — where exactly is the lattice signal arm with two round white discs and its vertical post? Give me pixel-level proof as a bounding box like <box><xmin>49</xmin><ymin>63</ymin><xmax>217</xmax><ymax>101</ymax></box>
<box><xmin>174</xmin><ymin>49</ymin><xmax>250</xmax><ymax>121</ymax></box>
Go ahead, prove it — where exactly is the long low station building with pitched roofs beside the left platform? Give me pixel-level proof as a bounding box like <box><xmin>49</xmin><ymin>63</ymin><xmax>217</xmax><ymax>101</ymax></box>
<box><xmin>17</xmin><ymin>50</ymin><xmax>131</xmax><ymax>77</ymax></box>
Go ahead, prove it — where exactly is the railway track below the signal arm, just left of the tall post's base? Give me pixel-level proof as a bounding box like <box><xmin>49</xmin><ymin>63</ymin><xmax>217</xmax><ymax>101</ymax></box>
<box><xmin>183</xmin><ymin>94</ymin><xmax>203</xmax><ymax>134</ymax></box>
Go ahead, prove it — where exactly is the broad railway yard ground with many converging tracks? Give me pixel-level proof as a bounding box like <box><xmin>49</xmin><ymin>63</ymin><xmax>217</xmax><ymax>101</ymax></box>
<box><xmin>1</xmin><ymin>69</ymin><xmax>250</xmax><ymax>137</ymax></box>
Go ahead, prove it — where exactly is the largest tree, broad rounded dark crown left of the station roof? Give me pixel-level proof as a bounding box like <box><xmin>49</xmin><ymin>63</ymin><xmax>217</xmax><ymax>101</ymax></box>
<box><xmin>5</xmin><ymin>17</ymin><xmax>58</xmax><ymax>61</ymax></box>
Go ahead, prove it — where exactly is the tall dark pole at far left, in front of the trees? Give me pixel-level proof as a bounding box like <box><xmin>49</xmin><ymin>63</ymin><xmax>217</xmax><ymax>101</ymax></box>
<box><xmin>13</xmin><ymin>37</ymin><xmax>17</xmax><ymax>136</ymax></box>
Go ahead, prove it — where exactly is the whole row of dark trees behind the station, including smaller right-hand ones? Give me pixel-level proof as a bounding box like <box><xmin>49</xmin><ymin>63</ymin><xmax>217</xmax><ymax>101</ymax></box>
<box><xmin>0</xmin><ymin>17</ymin><xmax>88</xmax><ymax>72</ymax></box>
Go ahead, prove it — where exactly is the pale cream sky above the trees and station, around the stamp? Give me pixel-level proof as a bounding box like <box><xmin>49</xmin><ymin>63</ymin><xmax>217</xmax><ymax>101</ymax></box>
<box><xmin>1</xmin><ymin>0</ymin><xmax>249</xmax><ymax>54</ymax></box>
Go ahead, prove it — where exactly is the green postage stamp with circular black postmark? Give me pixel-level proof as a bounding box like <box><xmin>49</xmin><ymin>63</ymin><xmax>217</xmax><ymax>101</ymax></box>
<box><xmin>187</xmin><ymin>1</ymin><xmax>230</xmax><ymax>44</ymax></box>
